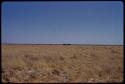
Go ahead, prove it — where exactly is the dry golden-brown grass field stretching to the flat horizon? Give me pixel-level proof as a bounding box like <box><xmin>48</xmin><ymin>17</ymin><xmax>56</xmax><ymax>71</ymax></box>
<box><xmin>1</xmin><ymin>45</ymin><xmax>123</xmax><ymax>83</ymax></box>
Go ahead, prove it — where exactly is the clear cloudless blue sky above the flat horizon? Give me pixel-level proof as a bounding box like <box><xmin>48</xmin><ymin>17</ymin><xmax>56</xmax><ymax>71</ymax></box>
<box><xmin>1</xmin><ymin>1</ymin><xmax>123</xmax><ymax>44</ymax></box>
